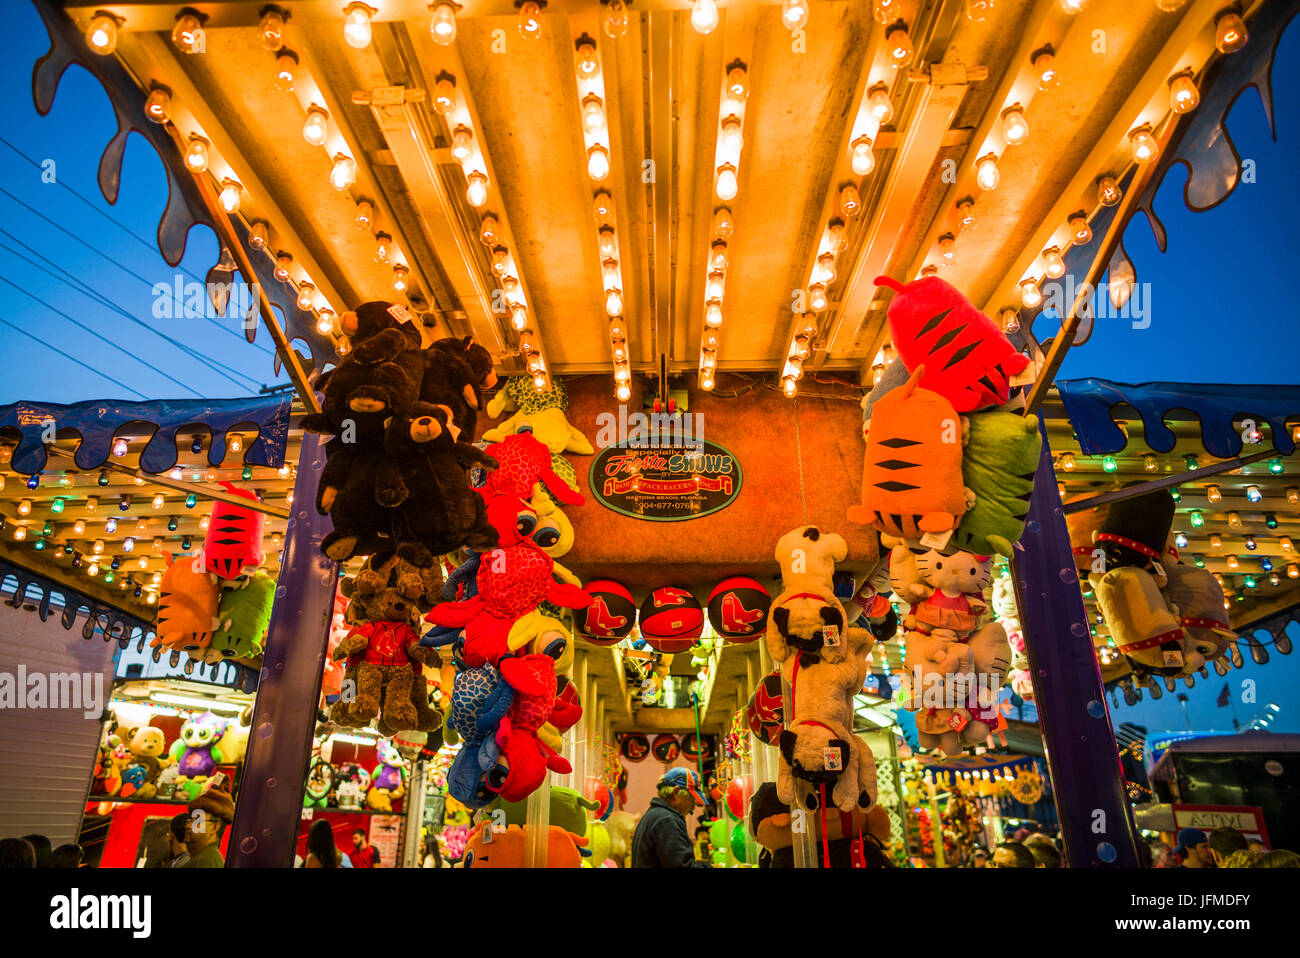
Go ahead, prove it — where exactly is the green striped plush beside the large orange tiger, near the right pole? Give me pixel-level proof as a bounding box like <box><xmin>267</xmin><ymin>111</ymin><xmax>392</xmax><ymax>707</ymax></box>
<box><xmin>953</xmin><ymin>411</ymin><xmax>1043</xmax><ymax>555</ymax></box>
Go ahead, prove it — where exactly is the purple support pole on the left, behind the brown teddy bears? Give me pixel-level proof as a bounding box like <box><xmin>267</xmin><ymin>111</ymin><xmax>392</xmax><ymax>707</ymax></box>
<box><xmin>226</xmin><ymin>433</ymin><xmax>338</xmax><ymax>868</ymax></box>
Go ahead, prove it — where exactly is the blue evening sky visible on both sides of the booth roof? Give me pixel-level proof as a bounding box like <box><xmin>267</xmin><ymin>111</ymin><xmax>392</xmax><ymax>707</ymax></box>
<box><xmin>0</xmin><ymin>3</ymin><xmax>1300</xmax><ymax>732</ymax></box>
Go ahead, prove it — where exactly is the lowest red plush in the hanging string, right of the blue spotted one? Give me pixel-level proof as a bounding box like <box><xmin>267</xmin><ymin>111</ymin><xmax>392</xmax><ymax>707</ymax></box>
<box><xmin>497</xmin><ymin>654</ymin><xmax>582</xmax><ymax>802</ymax></box>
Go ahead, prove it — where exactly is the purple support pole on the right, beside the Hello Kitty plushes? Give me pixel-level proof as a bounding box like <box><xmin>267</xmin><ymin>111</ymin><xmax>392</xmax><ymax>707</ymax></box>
<box><xmin>1011</xmin><ymin>416</ymin><xmax>1141</xmax><ymax>868</ymax></box>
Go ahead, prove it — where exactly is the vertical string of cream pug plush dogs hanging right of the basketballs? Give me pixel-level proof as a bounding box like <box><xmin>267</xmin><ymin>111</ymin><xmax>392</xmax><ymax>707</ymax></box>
<box><xmin>764</xmin><ymin>526</ymin><xmax>876</xmax><ymax>811</ymax></box>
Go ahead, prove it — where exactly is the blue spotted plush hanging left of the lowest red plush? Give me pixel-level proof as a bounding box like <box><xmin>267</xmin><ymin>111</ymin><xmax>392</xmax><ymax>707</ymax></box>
<box><xmin>447</xmin><ymin>657</ymin><xmax>515</xmax><ymax>809</ymax></box>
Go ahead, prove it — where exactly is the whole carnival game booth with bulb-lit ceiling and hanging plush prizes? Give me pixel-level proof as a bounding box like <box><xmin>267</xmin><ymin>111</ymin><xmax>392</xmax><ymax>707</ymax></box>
<box><xmin>0</xmin><ymin>0</ymin><xmax>1300</xmax><ymax>868</ymax></box>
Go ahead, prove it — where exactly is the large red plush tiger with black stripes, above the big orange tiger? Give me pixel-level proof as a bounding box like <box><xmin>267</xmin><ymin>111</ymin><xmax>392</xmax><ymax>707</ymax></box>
<box><xmin>876</xmin><ymin>276</ymin><xmax>1030</xmax><ymax>412</ymax></box>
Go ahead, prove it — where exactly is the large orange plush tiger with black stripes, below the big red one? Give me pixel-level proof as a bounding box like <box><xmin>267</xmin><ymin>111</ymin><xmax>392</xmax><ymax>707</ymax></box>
<box><xmin>849</xmin><ymin>365</ymin><xmax>969</xmax><ymax>539</ymax></box>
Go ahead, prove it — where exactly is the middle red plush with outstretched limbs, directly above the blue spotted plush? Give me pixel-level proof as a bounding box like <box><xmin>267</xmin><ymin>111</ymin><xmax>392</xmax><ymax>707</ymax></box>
<box><xmin>425</xmin><ymin>493</ymin><xmax>592</xmax><ymax>681</ymax></box>
